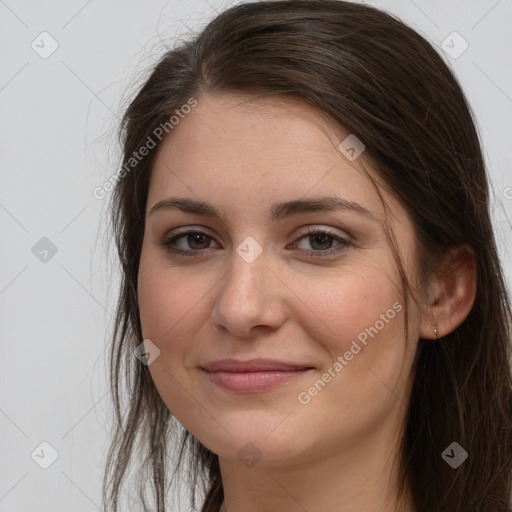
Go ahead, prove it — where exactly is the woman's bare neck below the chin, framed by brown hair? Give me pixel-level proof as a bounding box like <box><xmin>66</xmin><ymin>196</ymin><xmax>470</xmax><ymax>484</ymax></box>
<box><xmin>214</xmin><ymin>426</ymin><xmax>415</xmax><ymax>512</ymax></box>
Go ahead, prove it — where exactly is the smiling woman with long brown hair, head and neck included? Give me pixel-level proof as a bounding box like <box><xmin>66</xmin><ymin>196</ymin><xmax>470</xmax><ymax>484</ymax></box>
<box><xmin>104</xmin><ymin>0</ymin><xmax>512</xmax><ymax>512</ymax></box>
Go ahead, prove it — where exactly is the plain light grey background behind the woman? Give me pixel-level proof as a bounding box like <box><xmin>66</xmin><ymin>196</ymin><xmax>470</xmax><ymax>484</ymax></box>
<box><xmin>0</xmin><ymin>0</ymin><xmax>512</xmax><ymax>512</ymax></box>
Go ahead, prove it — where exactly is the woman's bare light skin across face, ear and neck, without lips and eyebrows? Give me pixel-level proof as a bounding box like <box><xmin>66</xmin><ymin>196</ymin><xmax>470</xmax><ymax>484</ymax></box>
<box><xmin>138</xmin><ymin>95</ymin><xmax>474</xmax><ymax>512</ymax></box>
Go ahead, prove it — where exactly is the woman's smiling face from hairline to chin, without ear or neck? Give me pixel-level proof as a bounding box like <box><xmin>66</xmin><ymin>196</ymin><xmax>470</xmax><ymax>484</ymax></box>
<box><xmin>138</xmin><ymin>95</ymin><xmax>420</xmax><ymax>465</ymax></box>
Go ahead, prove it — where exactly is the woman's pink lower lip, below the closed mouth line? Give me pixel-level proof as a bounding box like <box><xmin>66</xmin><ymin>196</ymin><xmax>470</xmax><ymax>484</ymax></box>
<box><xmin>201</xmin><ymin>368</ymin><xmax>311</xmax><ymax>392</ymax></box>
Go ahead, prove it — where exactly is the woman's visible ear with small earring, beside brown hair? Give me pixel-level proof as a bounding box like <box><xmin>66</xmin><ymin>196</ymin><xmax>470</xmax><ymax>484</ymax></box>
<box><xmin>419</xmin><ymin>245</ymin><xmax>477</xmax><ymax>340</ymax></box>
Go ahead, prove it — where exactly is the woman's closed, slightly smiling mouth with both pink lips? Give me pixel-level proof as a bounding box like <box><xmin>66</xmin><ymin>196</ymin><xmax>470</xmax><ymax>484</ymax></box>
<box><xmin>200</xmin><ymin>359</ymin><xmax>314</xmax><ymax>393</ymax></box>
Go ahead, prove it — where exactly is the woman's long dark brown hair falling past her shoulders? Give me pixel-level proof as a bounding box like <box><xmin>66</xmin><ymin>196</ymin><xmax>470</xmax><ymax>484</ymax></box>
<box><xmin>103</xmin><ymin>0</ymin><xmax>512</xmax><ymax>512</ymax></box>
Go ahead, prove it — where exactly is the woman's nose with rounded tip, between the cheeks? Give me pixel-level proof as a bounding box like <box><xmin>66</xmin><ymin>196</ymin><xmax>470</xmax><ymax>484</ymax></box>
<box><xmin>212</xmin><ymin>251</ymin><xmax>287</xmax><ymax>339</ymax></box>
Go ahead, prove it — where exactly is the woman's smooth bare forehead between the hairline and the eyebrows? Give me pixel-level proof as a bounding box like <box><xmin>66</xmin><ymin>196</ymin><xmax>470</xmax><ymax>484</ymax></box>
<box><xmin>148</xmin><ymin>95</ymin><xmax>408</xmax><ymax>228</ymax></box>
